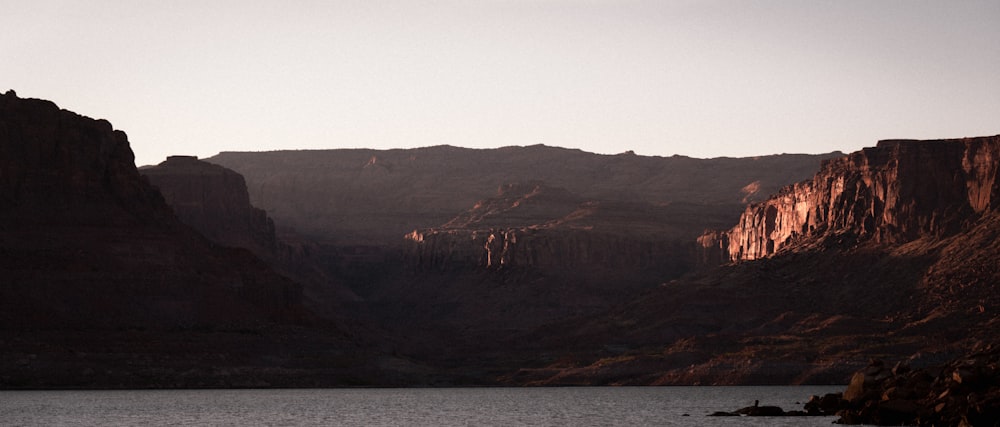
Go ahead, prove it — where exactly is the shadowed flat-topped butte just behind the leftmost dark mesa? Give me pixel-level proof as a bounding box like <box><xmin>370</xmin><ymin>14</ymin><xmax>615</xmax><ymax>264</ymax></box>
<box><xmin>140</xmin><ymin>156</ymin><xmax>278</xmax><ymax>259</ymax></box>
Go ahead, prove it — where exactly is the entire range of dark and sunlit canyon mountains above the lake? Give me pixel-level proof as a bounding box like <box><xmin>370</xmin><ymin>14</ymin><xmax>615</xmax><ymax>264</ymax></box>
<box><xmin>9</xmin><ymin>92</ymin><xmax>1000</xmax><ymax>392</ymax></box>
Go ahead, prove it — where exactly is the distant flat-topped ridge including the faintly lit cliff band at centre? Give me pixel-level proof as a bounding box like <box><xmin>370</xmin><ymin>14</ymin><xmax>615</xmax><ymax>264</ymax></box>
<box><xmin>207</xmin><ymin>145</ymin><xmax>842</xmax><ymax>280</ymax></box>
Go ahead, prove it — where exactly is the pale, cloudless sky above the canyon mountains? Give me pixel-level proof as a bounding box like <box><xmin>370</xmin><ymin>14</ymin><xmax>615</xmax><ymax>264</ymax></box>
<box><xmin>0</xmin><ymin>0</ymin><xmax>1000</xmax><ymax>165</ymax></box>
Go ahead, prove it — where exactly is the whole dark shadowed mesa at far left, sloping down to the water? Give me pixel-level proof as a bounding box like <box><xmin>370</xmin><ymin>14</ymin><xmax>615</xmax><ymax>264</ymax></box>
<box><xmin>0</xmin><ymin>91</ymin><xmax>377</xmax><ymax>388</ymax></box>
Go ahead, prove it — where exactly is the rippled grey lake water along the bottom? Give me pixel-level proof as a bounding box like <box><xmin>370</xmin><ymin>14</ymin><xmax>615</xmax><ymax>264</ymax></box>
<box><xmin>0</xmin><ymin>386</ymin><xmax>844</xmax><ymax>426</ymax></box>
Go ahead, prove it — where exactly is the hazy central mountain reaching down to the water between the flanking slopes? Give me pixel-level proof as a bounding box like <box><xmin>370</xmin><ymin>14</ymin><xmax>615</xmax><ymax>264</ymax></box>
<box><xmin>205</xmin><ymin>146</ymin><xmax>841</xmax><ymax>384</ymax></box>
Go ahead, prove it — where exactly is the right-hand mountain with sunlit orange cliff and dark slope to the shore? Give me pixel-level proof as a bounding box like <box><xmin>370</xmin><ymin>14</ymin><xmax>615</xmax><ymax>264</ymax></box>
<box><xmin>508</xmin><ymin>136</ymin><xmax>1000</xmax><ymax>384</ymax></box>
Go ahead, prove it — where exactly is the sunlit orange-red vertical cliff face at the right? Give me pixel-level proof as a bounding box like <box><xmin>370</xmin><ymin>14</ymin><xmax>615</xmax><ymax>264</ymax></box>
<box><xmin>701</xmin><ymin>136</ymin><xmax>1000</xmax><ymax>261</ymax></box>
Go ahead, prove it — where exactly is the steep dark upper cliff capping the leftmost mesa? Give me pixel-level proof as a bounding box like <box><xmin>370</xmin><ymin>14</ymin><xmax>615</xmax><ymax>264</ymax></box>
<box><xmin>0</xmin><ymin>91</ymin><xmax>172</xmax><ymax>226</ymax></box>
